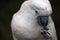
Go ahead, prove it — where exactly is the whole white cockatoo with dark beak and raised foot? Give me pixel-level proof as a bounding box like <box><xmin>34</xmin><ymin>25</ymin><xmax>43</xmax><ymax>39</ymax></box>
<box><xmin>11</xmin><ymin>0</ymin><xmax>57</xmax><ymax>40</ymax></box>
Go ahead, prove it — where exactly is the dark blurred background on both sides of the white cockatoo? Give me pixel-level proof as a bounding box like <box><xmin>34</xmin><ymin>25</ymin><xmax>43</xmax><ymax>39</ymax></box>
<box><xmin>0</xmin><ymin>0</ymin><xmax>60</xmax><ymax>40</ymax></box>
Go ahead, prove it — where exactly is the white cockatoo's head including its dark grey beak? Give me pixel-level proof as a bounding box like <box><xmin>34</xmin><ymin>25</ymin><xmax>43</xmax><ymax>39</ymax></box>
<box><xmin>21</xmin><ymin>0</ymin><xmax>52</xmax><ymax>26</ymax></box>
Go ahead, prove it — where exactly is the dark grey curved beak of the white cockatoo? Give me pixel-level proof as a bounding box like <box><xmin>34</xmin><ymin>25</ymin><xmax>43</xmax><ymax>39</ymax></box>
<box><xmin>37</xmin><ymin>16</ymin><xmax>49</xmax><ymax>27</ymax></box>
